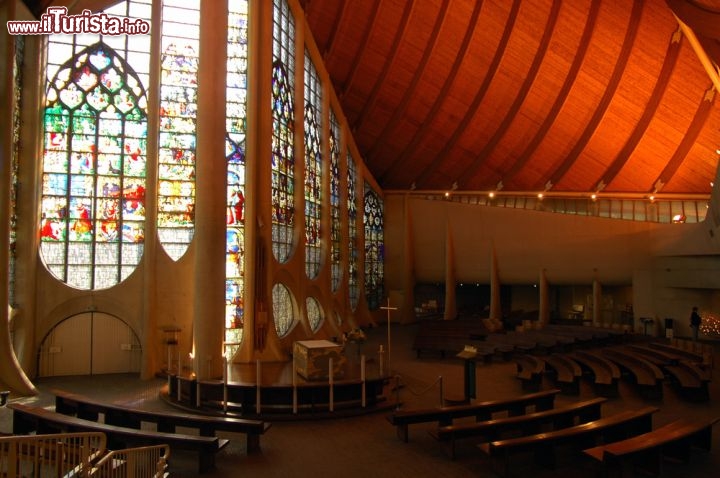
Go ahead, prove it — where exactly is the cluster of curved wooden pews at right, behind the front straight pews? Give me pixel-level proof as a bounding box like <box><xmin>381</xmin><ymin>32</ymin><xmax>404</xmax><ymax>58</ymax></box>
<box><xmin>515</xmin><ymin>342</ymin><xmax>711</xmax><ymax>402</ymax></box>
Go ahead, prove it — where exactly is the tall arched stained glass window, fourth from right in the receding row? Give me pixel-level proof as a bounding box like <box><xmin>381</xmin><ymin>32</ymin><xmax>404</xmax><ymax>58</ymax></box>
<box><xmin>305</xmin><ymin>50</ymin><xmax>323</xmax><ymax>279</ymax></box>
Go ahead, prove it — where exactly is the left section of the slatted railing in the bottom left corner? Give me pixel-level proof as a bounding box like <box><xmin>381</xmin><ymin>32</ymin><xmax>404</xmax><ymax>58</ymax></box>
<box><xmin>0</xmin><ymin>432</ymin><xmax>106</xmax><ymax>478</ymax></box>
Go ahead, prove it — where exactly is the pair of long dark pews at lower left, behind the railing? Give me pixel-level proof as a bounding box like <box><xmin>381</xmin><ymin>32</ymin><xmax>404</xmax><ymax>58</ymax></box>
<box><xmin>8</xmin><ymin>390</ymin><xmax>270</xmax><ymax>473</ymax></box>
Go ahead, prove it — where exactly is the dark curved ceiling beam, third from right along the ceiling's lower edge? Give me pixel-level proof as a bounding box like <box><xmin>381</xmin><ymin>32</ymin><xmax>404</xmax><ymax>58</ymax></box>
<box><xmin>537</xmin><ymin>2</ymin><xmax>645</xmax><ymax>190</ymax></box>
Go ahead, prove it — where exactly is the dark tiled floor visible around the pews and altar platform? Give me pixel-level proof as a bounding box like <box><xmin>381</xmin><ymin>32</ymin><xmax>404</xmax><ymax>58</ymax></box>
<box><xmin>0</xmin><ymin>326</ymin><xmax>720</xmax><ymax>478</ymax></box>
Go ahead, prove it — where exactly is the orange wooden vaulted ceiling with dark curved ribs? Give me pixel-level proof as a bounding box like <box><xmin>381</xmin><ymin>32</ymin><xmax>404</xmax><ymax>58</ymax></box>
<box><xmin>300</xmin><ymin>0</ymin><xmax>720</xmax><ymax>195</ymax></box>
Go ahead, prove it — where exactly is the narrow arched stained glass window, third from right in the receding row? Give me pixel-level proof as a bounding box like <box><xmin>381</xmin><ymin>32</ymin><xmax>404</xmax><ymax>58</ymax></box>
<box><xmin>330</xmin><ymin>110</ymin><xmax>342</xmax><ymax>292</ymax></box>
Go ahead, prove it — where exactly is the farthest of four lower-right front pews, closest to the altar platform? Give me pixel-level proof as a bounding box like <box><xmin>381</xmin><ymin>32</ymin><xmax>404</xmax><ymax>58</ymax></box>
<box><xmin>387</xmin><ymin>389</ymin><xmax>560</xmax><ymax>442</ymax></box>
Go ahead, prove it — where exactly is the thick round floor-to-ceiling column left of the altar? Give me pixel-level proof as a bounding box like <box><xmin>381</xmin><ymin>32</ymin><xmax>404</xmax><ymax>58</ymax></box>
<box><xmin>193</xmin><ymin>2</ymin><xmax>227</xmax><ymax>379</ymax></box>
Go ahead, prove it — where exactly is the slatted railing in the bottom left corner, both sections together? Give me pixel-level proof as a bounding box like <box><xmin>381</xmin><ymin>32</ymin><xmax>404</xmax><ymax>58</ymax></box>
<box><xmin>0</xmin><ymin>432</ymin><xmax>170</xmax><ymax>478</ymax></box>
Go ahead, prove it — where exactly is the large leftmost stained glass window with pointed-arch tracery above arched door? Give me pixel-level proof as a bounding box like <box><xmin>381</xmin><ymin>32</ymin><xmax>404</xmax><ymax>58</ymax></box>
<box><xmin>40</xmin><ymin>2</ymin><xmax>150</xmax><ymax>289</ymax></box>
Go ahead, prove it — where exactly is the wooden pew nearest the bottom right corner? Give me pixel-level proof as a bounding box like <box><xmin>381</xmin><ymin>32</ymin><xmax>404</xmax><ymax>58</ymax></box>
<box><xmin>583</xmin><ymin>418</ymin><xmax>720</xmax><ymax>476</ymax></box>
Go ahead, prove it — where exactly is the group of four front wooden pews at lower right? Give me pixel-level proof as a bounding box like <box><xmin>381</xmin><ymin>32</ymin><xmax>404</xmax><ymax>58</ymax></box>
<box><xmin>388</xmin><ymin>389</ymin><xmax>718</xmax><ymax>476</ymax></box>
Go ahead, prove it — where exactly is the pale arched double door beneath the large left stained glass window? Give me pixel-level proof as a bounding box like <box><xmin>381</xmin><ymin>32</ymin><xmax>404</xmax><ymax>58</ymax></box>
<box><xmin>38</xmin><ymin>312</ymin><xmax>142</xmax><ymax>377</ymax></box>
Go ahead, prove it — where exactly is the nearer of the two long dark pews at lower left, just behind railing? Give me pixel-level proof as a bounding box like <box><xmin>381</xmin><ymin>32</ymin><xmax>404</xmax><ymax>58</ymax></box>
<box><xmin>9</xmin><ymin>403</ymin><xmax>229</xmax><ymax>473</ymax></box>
